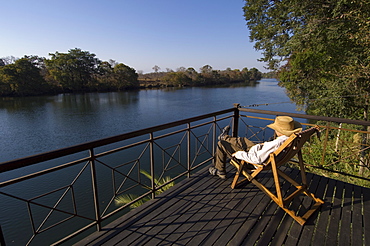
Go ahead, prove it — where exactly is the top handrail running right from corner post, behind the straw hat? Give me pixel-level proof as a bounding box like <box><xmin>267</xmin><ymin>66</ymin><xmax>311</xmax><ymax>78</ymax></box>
<box><xmin>239</xmin><ymin>108</ymin><xmax>370</xmax><ymax>126</ymax></box>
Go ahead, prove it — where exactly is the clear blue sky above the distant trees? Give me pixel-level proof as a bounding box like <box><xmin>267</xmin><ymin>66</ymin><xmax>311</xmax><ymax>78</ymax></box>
<box><xmin>0</xmin><ymin>0</ymin><xmax>266</xmax><ymax>73</ymax></box>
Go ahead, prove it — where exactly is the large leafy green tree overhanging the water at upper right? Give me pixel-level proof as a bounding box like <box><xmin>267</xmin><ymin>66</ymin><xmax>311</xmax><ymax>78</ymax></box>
<box><xmin>244</xmin><ymin>0</ymin><xmax>370</xmax><ymax>120</ymax></box>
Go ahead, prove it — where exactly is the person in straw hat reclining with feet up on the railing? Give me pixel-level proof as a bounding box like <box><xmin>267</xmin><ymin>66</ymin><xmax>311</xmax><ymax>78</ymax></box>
<box><xmin>209</xmin><ymin>116</ymin><xmax>302</xmax><ymax>179</ymax></box>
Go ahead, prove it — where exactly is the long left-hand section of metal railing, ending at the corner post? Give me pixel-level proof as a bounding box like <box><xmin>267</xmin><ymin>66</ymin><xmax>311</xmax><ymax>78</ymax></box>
<box><xmin>0</xmin><ymin>108</ymin><xmax>236</xmax><ymax>245</ymax></box>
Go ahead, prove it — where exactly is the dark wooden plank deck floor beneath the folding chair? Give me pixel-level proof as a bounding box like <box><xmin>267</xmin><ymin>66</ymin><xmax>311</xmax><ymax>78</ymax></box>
<box><xmin>77</xmin><ymin>168</ymin><xmax>370</xmax><ymax>246</ymax></box>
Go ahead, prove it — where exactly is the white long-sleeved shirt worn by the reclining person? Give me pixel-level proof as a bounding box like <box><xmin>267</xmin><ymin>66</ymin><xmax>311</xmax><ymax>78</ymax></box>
<box><xmin>233</xmin><ymin>135</ymin><xmax>289</xmax><ymax>164</ymax></box>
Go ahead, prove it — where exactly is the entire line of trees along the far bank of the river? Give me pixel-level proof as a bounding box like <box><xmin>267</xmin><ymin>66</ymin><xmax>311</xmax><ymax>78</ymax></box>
<box><xmin>0</xmin><ymin>48</ymin><xmax>262</xmax><ymax>96</ymax></box>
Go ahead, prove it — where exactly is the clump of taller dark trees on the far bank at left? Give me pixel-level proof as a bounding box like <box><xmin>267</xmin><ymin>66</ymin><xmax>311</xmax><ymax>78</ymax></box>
<box><xmin>0</xmin><ymin>48</ymin><xmax>139</xmax><ymax>96</ymax></box>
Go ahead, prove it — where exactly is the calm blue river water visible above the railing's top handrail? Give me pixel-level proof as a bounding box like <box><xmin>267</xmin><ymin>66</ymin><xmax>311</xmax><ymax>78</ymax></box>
<box><xmin>0</xmin><ymin>79</ymin><xmax>302</xmax><ymax>162</ymax></box>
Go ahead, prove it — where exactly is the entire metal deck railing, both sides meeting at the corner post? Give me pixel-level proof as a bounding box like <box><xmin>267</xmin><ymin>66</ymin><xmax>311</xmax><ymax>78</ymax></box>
<box><xmin>0</xmin><ymin>104</ymin><xmax>370</xmax><ymax>245</ymax></box>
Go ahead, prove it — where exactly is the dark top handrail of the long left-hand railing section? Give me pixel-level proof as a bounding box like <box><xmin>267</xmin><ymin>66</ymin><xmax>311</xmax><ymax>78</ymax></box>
<box><xmin>0</xmin><ymin>108</ymin><xmax>234</xmax><ymax>172</ymax></box>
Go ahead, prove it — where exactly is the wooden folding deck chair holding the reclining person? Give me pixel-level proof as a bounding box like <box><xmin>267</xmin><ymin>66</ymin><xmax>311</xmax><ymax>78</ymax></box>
<box><xmin>230</xmin><ymin>127</ymin><xmax>324</xmax><ymax>225</ymax></box>
